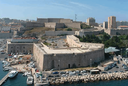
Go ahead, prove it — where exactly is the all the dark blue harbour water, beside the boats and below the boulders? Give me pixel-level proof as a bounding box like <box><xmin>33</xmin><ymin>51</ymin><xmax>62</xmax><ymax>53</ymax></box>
<box><xmin>0</xmin><ymin>61</ymin><xmax>128</xmax><ymax>86</ymax></box>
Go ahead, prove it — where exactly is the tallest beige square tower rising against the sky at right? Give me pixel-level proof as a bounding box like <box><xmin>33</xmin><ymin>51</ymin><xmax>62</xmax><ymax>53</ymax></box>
<box><xmin>108</xmin><ymin>16</ymin><xmax>116</xmax><ymax>29</ymax></box>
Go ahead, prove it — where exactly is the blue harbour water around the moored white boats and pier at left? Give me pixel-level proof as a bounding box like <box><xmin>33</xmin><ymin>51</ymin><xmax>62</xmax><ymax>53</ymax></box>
<box><xmin>0</xmin><ymin>61</ymin><xmax>33</xmax><ymax>86</ymax></box>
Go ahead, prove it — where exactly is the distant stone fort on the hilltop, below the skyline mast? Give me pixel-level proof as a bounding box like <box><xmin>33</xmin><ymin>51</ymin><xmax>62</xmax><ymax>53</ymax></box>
<box><xmin>26</xmin><ymin>18</ymin><xmax>82</xmax><ymax>29</ymax></box>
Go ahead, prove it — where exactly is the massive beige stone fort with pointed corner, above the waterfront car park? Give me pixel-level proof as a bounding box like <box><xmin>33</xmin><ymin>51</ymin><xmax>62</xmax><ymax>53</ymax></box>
<box><xmin>33</xmin><ymin>35</ymin><xmax>104</xmax><ymax>70</ymax></box>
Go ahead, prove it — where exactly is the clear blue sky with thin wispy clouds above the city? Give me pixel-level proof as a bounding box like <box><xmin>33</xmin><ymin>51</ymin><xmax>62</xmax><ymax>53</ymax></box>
<box><xmin>0</xmin><ymin>0</ymin><xmax>128</xmax><ymax>23</ymax></box>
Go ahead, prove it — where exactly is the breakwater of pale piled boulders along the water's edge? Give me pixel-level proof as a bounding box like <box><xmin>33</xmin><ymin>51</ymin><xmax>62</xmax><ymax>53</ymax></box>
<box><xmin>49</xmin><ymin>72</ymin><xmax>128</xmax><ymax>85</ymax></box>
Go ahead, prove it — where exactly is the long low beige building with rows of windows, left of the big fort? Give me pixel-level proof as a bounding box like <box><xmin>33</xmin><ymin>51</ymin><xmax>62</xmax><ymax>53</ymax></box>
<box><xmin>6</xmin><ymin>38</ymin><xmax>38</xmax><ymax>54</ymax></box>
